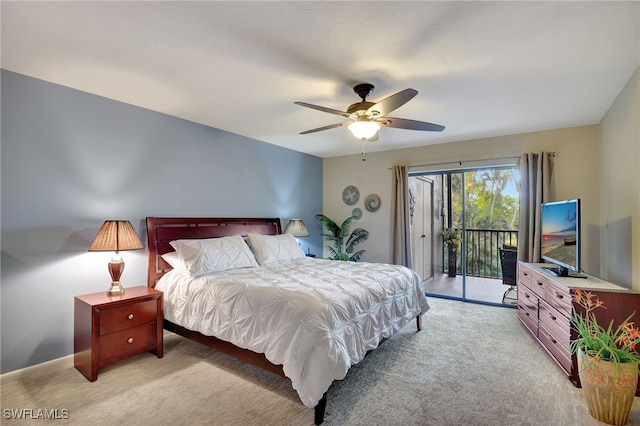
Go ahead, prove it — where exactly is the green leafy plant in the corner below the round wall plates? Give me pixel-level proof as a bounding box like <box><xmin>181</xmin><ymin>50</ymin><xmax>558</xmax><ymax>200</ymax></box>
<box><xmin>316</xmin><ymin>214</ymin><xmax>369</xmax><ymax>262</ymax></box>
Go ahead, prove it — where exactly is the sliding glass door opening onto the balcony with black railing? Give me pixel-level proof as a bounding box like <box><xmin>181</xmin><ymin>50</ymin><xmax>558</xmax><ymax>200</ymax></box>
<box><xmin>409</xmin><ymin>167</ymin><xmax>519</xmax><ymax>305</ymax></box>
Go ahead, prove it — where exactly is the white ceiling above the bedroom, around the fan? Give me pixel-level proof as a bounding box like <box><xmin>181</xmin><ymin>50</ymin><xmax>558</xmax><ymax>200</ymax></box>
<box><xmin>1</xmin><ymin>1</ymin><xmax>640</xmax><ymax>157</ymax></box>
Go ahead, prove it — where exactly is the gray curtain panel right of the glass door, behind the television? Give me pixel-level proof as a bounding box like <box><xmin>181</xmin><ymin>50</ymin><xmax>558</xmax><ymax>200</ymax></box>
<box><xmin>518</xmin><ymin>151</ymin><xmax>551</xmax><ymax>263</ymax></box>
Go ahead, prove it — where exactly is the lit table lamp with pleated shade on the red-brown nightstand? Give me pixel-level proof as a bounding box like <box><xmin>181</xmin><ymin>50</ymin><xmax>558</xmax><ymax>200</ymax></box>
<box><xmin>89</xmin><ymin>220</ymin><xmax>144</xmax><ymax>295</ymax></box>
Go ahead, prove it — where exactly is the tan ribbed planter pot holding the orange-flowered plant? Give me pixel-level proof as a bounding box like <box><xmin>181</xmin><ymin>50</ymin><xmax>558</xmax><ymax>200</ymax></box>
<box><xmin>577</xmin><ymin>349</ymin><xmax>638</xmax><ymax>425</ymax></box>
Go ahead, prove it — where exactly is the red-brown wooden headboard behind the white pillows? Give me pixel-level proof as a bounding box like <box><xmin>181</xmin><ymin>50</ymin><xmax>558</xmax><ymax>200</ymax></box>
<box><xmin>147</xmin><ymin>217</ymin><xmax>282</xmax><ymax>287</ymax></box>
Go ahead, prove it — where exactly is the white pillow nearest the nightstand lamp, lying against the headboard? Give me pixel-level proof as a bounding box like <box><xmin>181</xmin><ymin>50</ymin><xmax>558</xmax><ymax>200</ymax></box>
<box><xmin>169</xmin><ymin>235</ymin><xmax>258</xmax><ymax>277</ymax></box>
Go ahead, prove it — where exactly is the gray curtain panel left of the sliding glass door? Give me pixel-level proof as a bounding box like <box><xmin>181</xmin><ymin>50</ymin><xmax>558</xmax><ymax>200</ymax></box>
<box><xmin>391</xmin><ymin>166</ymin><xmax>412</xmax><ymax>268</ymax></box>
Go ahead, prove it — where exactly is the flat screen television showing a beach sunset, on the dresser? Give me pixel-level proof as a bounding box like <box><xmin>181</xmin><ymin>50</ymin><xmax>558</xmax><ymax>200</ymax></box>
<box><xmin>541</xmin><ymin>199</ymin><xmax>583</xmax><ymax>277</ymax></box>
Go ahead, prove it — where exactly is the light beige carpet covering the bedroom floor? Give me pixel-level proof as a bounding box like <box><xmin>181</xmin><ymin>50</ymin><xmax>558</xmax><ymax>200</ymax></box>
<box><xmin>0</xmin><ymin>298</ymin><xmax>640</xmax><ymax>426</ymax></box>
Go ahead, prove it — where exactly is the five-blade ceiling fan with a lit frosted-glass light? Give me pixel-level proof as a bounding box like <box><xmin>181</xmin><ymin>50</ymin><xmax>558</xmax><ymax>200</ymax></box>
<box><xmin>294</xmin><ymin>83</ymin><xmax>444</xmax><ymax>141</ymax></box>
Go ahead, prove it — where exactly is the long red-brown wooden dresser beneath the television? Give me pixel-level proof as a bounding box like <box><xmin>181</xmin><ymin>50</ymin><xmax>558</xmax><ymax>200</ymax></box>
<box><xmin>518</xmin><ymin>262</ymin><xmax>640</xmax><ymax>396</ymax></box>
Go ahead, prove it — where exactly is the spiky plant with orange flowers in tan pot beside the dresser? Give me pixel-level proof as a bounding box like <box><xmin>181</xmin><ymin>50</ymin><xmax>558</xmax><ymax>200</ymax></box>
<box><xmin>571</xmin><ymin>289</ymin><xmax>640</xmax><ymax>425</ymax></box>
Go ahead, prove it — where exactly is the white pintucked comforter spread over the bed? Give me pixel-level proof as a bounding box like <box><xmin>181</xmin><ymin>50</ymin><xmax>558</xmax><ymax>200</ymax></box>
<box><xmin>156</xmin><ymin>258</ymin><xmax>429</xmax><ymax>408</ymax></box>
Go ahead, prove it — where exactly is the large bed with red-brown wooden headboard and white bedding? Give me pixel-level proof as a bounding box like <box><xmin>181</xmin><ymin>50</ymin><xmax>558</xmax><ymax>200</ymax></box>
<box><xmin>146</xmin><ymin>217</ymin><xmax>429</xmax><ymax>424</ymax></box>
